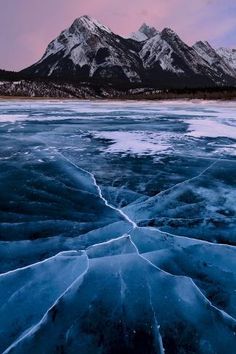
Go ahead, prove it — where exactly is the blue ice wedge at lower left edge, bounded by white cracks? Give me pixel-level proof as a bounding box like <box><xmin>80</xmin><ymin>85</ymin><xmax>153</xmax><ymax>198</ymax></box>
<box><xmin>0</xmin><ymin>252</ymin><xmax>87</xmax><ymax>352</ymax></box>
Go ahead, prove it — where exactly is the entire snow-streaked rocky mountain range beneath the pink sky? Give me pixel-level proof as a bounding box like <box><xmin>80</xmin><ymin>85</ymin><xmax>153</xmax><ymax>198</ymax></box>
<box><xmin>21</xmin><ymin>16</ymin><xmax>236</xmax><ymax>88</ymax></box>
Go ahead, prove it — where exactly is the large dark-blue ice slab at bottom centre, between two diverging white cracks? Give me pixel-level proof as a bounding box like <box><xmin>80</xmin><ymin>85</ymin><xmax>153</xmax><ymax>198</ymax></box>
<box><xmin>2</xmin><ymin>238</ymin><xmax>236</xmax><ymax>353</ymax></box>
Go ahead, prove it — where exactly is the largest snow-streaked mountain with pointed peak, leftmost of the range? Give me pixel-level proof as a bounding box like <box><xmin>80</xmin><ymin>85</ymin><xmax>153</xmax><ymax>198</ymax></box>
<box><xmin>21</xmin><ymin>16</ymin><xmax>142</xmax><ymax>82</ymax></box>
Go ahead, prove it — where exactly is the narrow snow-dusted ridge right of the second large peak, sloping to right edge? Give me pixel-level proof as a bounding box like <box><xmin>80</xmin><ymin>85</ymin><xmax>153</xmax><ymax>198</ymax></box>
<box><xmin>193</xmin><ymin>41</ymin><xmax>236</xmax><ymax>80</ymax></box>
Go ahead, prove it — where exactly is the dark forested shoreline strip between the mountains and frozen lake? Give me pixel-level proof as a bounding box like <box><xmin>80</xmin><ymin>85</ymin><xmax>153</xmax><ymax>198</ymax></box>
<box><xmin>0</xmin><ymin>80</ymin><xmax>236</xmax><ymax>102</ymax></box>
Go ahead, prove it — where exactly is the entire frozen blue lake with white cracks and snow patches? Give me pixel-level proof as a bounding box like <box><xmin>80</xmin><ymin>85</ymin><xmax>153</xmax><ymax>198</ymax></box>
<box><xmin>0</xmin><ymin>100</ymin><xmax>236</xmax><ymax>354</ymax></box>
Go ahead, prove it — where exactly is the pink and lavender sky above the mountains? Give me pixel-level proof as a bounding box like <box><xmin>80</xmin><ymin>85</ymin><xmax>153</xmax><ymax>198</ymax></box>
<box><xmin>0</xmin><ymin>0</ymin><xmax>236</xmax><ymax>70</ymax></box>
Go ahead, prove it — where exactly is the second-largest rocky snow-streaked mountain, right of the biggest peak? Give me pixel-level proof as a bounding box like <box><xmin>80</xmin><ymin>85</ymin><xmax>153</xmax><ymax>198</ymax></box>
<box><xmin>140</xmin><ymin>28</ymin><xmax>230</xmax><ymax>87</ymax></box>
